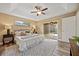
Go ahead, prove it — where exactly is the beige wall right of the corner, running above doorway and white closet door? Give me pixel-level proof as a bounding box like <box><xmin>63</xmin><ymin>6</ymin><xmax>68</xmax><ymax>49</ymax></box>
<box><xmin>36</xmin><ymin>11</ymin><xmax>76</xmax><ymax>36</ymax></box>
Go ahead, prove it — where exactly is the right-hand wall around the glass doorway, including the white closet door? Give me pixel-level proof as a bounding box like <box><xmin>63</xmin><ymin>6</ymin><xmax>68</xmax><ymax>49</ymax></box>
<box><xmin>37</xmin><ymin>11</ymin><xmax>79</xmax><ymax>42</ymax></box>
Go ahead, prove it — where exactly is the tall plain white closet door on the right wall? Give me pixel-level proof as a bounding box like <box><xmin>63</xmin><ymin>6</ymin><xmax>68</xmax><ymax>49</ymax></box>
<box><xmin>62</xmin><ymin>16</ymin><xmax>76</xmax><ymax>42</ymax></box>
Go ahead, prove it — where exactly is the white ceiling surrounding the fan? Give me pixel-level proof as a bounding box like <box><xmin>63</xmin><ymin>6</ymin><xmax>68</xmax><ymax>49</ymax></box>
<box><xmin>0</xmin><ymin>3</ymin><xmax>78</xmax><ymax>21</ymax></box>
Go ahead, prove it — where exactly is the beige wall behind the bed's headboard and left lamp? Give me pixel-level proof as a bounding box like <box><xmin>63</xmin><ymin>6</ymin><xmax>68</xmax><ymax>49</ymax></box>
<box><xmin>0</xmin><ymin>13</ymin><xmax>36</xmax><ymax>34</ymax></box>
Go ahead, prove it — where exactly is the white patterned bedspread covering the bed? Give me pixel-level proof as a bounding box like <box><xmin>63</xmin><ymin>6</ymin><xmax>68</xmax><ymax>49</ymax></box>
<box><xmin>15</xmin><ymin>34</ymin><xmax>44</xmax><ymax>51</ymax></box>
